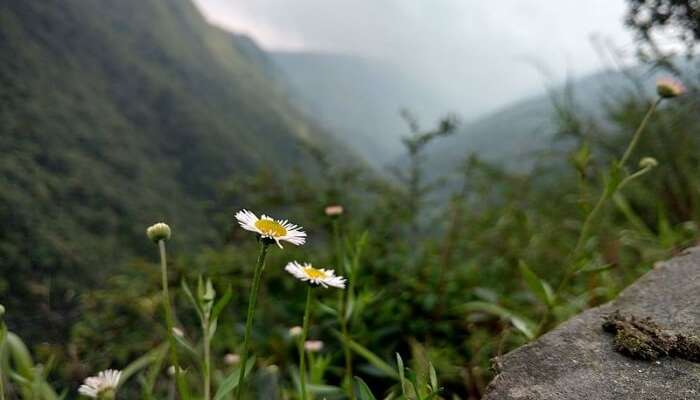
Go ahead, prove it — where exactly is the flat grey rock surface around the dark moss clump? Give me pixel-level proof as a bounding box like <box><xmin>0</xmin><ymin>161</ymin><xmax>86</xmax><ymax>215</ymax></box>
<box><xmin>484</xmin><ymin>247</ymin><xmax>700</xmax><ymax>400</ymax></box>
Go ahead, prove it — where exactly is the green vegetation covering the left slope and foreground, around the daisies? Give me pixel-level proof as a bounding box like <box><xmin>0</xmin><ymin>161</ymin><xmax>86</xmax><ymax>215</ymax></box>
<box><xmin>0</xmin><ymin>0</ymin><xmax>700</xmax><ymax>400</ymax></box>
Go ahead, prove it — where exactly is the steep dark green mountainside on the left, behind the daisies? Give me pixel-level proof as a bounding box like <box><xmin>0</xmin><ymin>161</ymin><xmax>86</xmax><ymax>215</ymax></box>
<box><xmin>0</xmin><ymin>0</ymin><xmax>342</xmax><ymax>339</ymax></box>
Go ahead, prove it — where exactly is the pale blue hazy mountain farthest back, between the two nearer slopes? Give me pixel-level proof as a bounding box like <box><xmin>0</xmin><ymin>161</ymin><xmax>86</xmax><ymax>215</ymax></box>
<box><xmin>269</xmin><ymin>52</ymin><xmax>454</xmax><ymax>166</ymax></box>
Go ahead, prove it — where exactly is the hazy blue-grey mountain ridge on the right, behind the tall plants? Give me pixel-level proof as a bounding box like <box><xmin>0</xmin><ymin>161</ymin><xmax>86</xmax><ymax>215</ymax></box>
<box><xmin>427</xmin><ymin>67</ymin><xmax>655</xmax><ymax>175</ymax></box>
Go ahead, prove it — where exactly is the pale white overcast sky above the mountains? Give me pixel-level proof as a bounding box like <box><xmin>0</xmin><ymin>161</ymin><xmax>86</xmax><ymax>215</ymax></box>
<box><xmin>191</xmin><ymin>0</ymin><xmax>633</xmax><ymax>116</ymax></box>
